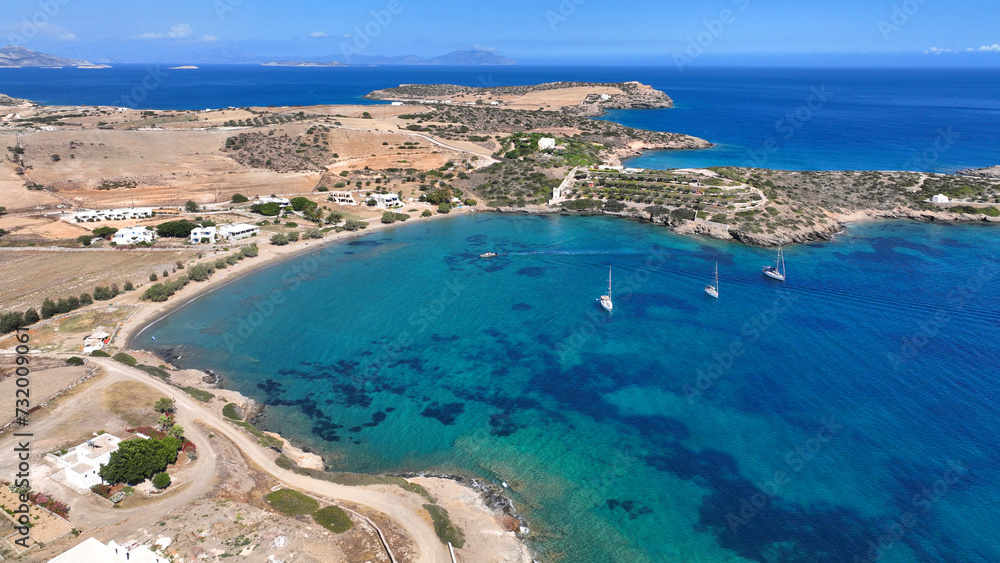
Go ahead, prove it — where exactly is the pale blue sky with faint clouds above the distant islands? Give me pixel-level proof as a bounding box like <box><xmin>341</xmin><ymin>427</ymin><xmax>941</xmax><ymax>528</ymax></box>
<box><xmin>0</xmin><ymin>0</ymin><xmax>1000</xmax><ymax>66</ymax></box>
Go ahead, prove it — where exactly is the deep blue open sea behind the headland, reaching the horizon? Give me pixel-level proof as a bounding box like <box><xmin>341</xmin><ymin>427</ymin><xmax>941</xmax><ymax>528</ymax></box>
<box><xmin>0</xmin><ymin>65</ymin><xmax>1000</xmax><ymax>172</ymax></box>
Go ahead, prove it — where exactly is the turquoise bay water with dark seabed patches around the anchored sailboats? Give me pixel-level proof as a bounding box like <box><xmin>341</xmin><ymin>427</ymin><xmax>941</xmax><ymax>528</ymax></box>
<box><xmin>139</xmin><ymin>214</ymin><xmax>1000</xmax><ymax>563</ymax></box>
